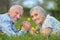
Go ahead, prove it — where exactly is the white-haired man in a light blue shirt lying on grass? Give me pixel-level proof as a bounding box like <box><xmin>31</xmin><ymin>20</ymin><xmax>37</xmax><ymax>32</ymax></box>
<box><xmin>0</xmin><ymin>5</ymin><xmax>26</xmax><ymax>36</ymax></box>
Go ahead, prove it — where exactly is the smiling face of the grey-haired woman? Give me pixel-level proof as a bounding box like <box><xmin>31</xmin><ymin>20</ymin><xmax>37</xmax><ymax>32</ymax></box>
<box><xmin>30</xmin><ymin>10</ymin><xmax>45</xmax><ymax>24</ymax></box>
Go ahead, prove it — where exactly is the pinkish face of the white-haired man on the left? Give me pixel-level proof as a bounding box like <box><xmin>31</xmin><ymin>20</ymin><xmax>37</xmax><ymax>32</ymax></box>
<box><xmin>10</xmin><ymin>8</ymin><xmax>23</xmax><ymax>22</ymax></box>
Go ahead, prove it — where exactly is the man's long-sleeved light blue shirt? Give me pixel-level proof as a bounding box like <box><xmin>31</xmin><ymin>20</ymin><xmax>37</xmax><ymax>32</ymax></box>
<box><xmin>0</xmin><ymin>13</ymin><xmax>26</xmax><ymax>36</ymax></box>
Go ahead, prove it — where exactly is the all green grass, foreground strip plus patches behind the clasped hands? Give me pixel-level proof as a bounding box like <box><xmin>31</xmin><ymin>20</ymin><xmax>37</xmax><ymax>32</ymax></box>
<box><xmin>0</xmin><ymin>17</ymin><xmax>60</xmax><ymax>40</ymax></box>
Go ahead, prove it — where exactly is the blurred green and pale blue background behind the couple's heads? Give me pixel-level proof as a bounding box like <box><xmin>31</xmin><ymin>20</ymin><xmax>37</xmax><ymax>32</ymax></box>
<box><xmin>0</xmin><ymin>0</ymin><xmax>60</xmax><ymax>27</ymax></box>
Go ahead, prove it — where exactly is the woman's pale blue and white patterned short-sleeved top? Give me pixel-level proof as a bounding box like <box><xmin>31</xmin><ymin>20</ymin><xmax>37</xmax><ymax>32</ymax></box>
<box><xmin>42</xmin><ymin>15</ymin><xmax>60</xmax><ymax>35</ymax></box>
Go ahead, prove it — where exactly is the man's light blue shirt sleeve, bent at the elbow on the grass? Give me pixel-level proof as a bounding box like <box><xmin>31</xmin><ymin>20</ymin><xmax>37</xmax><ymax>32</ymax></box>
<box><xmin>1</xmin><ymin>23</ymin><xmax>26</xmax><ymax>36</ymax></box>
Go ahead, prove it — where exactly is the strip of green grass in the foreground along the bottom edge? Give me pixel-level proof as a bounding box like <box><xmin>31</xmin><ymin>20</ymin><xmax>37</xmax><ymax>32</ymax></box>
<box><xmin>0</xmin><ymin>33</ymin><xmax>60</xmax><ymax>40</ymax></box>
